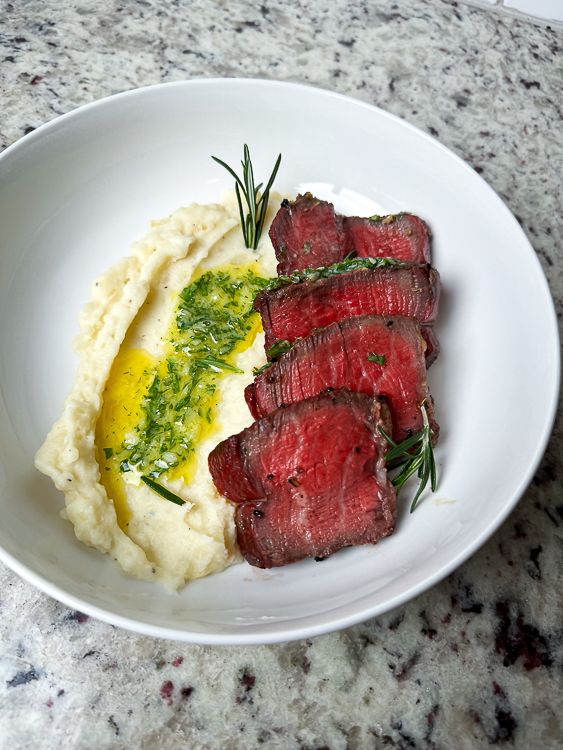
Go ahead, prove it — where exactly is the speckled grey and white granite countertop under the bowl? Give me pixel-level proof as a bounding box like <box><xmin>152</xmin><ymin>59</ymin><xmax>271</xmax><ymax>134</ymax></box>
<box><xmin>0</xmin><ymin>0</ymin><xmax>563</xmax><ymax>750</ymax></box>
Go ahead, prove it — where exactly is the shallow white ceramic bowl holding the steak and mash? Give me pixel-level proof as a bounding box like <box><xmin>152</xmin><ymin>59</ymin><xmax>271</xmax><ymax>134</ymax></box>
<box><xmin>0</xmin><ymin>79</ymin><xmax>559</xmax><ymax>644</ymax></box>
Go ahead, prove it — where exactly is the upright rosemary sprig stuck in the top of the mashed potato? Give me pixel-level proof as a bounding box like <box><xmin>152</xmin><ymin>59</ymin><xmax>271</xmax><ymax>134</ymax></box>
<box><xmin>211</xmin><ymin>143</ymin><xmax>281</xmax><ymax>250</ymax></box>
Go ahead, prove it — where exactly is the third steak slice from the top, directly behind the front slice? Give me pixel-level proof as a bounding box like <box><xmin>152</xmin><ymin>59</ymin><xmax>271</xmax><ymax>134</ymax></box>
<box><xmin>245</xmin><ymin>315</ymin><xmax>440</xmax><ymax>443</ymax></box>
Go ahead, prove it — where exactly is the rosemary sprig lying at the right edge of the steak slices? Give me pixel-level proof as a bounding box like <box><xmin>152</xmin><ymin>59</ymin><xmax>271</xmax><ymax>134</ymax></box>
<box><xmin>379</xmin><ymin>402</ymin><xmax>436</xmax><ymax>513</ymax></box>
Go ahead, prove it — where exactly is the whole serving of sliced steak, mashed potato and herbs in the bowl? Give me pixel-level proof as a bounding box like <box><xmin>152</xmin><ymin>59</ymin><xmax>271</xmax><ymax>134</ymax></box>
<box><xmin>36</xmin><ymin>147</ymin><xmax>440</xmax><ymax>591</ymax></box>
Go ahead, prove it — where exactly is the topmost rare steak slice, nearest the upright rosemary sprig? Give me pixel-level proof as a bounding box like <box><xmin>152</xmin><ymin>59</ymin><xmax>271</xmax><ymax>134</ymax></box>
<box><xmin>270</xmin><ymin>193</ymin><xmax>430</xmax><ymax>276</ymax></box>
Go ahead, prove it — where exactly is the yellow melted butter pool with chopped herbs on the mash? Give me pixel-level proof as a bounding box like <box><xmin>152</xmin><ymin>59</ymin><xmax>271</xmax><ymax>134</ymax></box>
<box><xmin>96</xmin><ymin>264</ymin><xmax>268</xmax><ymax>530</ymax></box>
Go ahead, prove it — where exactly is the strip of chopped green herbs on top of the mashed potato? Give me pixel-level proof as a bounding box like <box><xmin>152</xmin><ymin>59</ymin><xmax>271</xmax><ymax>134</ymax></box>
<box><xmin>112</xmin><ymin>267</ymin><xmax>267</xmax><ymax>479</ymax></box>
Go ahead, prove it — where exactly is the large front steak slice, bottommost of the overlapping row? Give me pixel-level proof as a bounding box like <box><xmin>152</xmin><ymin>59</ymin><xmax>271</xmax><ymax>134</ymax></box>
<box><xmin>209</xmin><ymin>389</ymin><xmax>397</xmax><ymax>568</ymax></box>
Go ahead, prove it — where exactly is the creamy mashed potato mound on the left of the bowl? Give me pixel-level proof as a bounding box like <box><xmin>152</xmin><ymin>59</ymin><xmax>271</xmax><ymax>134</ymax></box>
<box><xmin>36</xmin><ymin>191</ymin><xmax>282</xmax><ymax>591</ymax></box>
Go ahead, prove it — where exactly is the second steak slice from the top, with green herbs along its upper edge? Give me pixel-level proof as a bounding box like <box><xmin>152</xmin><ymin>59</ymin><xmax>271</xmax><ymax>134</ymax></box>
<box><xmin>254</xmin><ymin>263</ymin><xmax>441</xmax><ymax>349</ymax></box>
